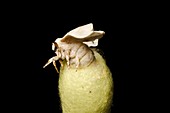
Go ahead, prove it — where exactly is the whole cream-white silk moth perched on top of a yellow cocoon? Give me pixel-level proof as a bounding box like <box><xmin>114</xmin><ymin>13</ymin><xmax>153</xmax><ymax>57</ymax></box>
<box><xmin>44</xmin><ymin>23</ymin><xmax>105</xmax><ymax>72</ymax></box>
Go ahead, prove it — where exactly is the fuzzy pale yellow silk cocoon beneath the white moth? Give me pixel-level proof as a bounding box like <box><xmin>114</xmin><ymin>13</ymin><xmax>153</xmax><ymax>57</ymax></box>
<box><xmin>59</xmin><ymin>51</ymin><xmax>113</xmax><ymax>113</ymax></box>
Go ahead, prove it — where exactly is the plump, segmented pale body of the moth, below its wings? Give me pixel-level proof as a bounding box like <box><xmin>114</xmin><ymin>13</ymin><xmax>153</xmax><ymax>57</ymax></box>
<box><xmin>56</xmin><ymin>41</ymin><xmax>94</xmax><ymax>68</ymax></box>
